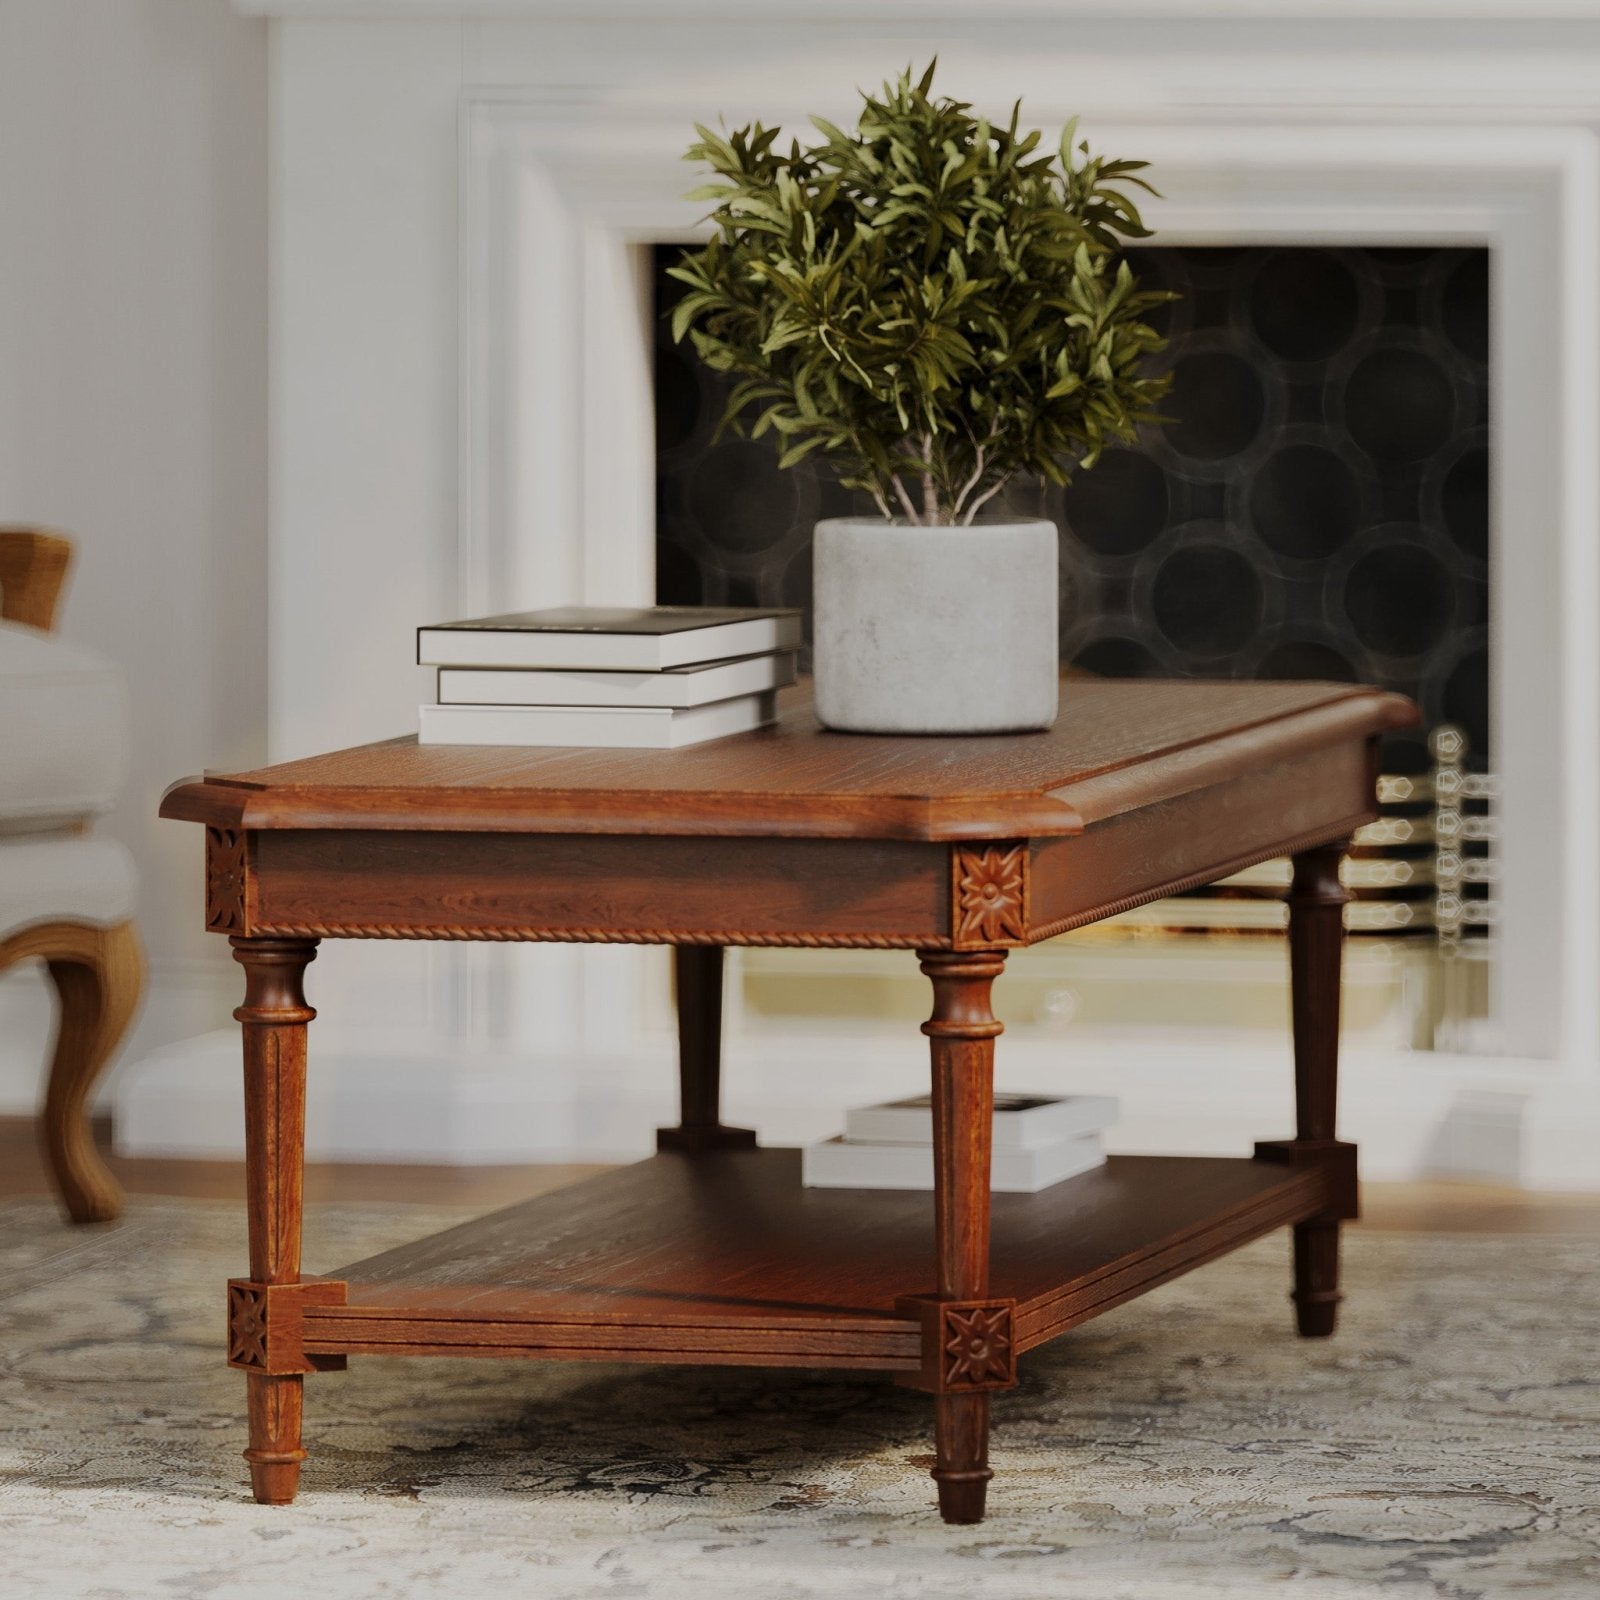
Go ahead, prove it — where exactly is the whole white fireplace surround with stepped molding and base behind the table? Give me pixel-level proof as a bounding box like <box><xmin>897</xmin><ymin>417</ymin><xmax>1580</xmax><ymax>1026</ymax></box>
<box><xmin>118</xmin><ymin>9</ymin><xmax>1600</xmax><ymax>1186</ymax></box>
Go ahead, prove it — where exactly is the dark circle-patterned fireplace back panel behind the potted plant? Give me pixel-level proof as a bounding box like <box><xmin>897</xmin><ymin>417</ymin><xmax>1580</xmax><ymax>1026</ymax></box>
<box><xmin>654</xmin><ymin>245</ymin><xmax>1490</xmax><ymax>773</ymax></box>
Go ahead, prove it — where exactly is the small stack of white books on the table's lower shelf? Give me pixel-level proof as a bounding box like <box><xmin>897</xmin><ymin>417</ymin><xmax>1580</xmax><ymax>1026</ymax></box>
<box><xmin>800</xmin><ymin>1094</ymin><xmax>1117</xmax><ymax>1194</ymax></box>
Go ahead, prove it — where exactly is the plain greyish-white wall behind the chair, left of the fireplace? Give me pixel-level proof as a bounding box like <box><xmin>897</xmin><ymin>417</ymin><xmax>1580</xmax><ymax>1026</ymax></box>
<box><xmin>0</xmin><ymin>0</ymin><xmax>267</xmax><ymax>1112</ymax></box>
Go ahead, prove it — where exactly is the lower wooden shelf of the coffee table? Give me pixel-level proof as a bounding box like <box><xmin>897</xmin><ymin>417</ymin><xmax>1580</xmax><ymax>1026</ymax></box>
<box><xmin>291</xmin><ymin>1149</ymin><xmax>1330</xmax><ymax>1371</ymax></box>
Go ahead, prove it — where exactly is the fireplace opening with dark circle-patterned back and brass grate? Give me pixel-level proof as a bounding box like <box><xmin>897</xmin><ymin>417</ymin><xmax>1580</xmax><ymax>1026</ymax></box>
<box><xmin>651</xmin><ymin>246</ymin><xmax>1494</xmax><ymax>1048</ymax></box>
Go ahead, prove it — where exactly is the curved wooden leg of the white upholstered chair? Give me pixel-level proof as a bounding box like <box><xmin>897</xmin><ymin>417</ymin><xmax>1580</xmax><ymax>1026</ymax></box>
<box><xmin>24</xmin><ymin>922</ymin><xmax>144</xmax><ymax>1222</ymax></box>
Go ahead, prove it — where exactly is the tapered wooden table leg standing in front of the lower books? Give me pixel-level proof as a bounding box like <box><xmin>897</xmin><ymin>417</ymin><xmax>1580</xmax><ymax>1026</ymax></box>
<box><xmin>922</xmin><ymin>950</ymin><xmax>1010</xmax><ymax>1523</ymax></box>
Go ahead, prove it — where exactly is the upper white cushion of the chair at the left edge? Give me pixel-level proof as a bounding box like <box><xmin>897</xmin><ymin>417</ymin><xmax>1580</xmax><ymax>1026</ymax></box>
<box><xmin>0</xmin><ymin>622</ymin><xmax>128</xmax><ymax>834</ymax></box>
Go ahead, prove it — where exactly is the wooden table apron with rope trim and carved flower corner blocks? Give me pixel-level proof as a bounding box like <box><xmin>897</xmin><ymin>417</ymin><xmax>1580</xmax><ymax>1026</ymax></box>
<box><xmin>208</xmin><ymin>741</ymin><xmax>1376</xmax><ymax>950</ymax></box>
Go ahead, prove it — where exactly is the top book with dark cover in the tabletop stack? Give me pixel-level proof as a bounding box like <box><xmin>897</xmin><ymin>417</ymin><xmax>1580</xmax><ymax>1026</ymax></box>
<box><xmin>416</xmin><ymin>605</ymin><xmax>800</xmax><ymax>672</ymax></box>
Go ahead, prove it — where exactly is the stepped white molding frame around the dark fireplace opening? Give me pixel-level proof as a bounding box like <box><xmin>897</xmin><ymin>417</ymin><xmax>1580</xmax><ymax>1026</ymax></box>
<box><xmin>458</xmin><ymin>96</ymin><xmax>1600</xmax><ymax>1078</ymax></box>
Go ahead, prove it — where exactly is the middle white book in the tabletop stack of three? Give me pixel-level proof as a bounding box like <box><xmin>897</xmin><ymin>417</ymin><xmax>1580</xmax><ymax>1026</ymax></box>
<box><xmin>438</xmin><ymin>650</ymin><xmax>795</xmax><ymax>707</ymax></box>
